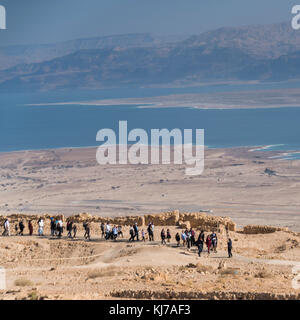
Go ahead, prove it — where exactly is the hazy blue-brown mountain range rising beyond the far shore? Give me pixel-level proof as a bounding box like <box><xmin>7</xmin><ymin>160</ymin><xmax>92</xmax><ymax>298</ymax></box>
<box><xmin>0</xmin><ymin>23</ymin><xmax>300</xmax><ymax>91</ymax></box>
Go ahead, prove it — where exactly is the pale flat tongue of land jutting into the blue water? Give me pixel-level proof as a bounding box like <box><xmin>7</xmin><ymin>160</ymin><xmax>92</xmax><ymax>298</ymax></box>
<box><xmin>22</xmin><ymin>88</ymin><xmax>300</xmax><ymax>110</ymax></box>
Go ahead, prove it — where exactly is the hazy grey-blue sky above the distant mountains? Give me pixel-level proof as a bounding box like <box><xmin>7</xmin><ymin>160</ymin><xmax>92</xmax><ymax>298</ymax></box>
<box><xmin>0</xmin><ymin>0</ymin><xmax>300</xmax><ymax>46</ymax></box>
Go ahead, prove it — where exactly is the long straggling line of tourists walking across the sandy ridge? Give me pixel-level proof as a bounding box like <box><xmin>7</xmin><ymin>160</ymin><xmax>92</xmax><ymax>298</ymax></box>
<box><xmin>2</xmin><ymin>217</ymin><xmax>232</xmax><ymax>258</ymax></box>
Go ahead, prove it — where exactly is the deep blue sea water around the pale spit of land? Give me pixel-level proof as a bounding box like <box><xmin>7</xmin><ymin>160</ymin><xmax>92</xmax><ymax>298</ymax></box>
<box><xmin>0</xmin><ymin>84</ymin><xmax>300</xmax><ymax>158</ymax></box>
